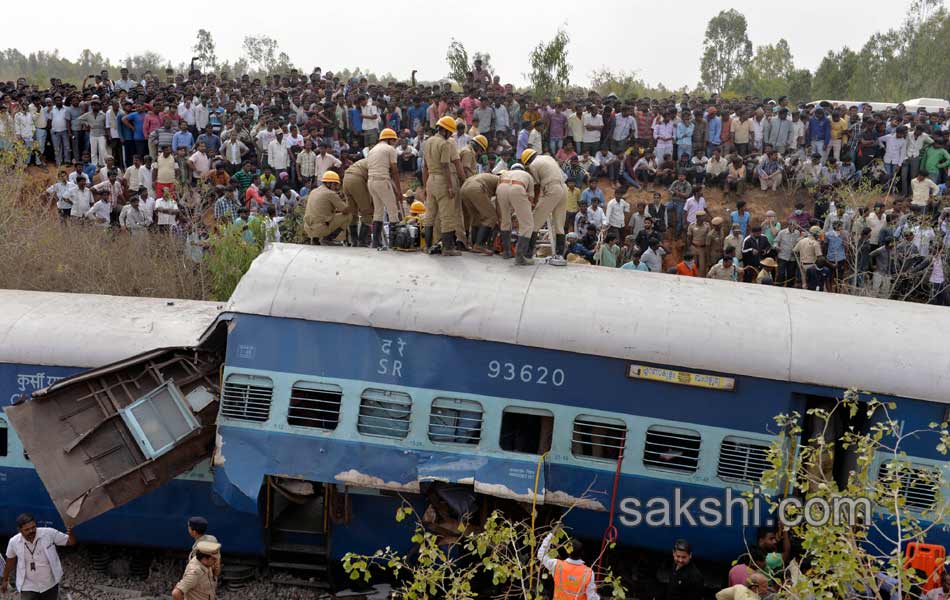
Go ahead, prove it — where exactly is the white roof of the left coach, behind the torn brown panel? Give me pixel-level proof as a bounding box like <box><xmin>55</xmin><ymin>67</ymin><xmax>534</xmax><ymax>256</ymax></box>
<box><xmin>0</xmin><ymin>290</ymin><xmax>223</xmax><ymax>368</ymax></box>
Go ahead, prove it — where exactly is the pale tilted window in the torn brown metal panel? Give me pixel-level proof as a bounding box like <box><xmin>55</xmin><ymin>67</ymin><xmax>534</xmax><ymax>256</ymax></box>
<box><xmin>119</xmin><ymin>381</ymin><xmax>200</xmax><ymax>458</ymax></box>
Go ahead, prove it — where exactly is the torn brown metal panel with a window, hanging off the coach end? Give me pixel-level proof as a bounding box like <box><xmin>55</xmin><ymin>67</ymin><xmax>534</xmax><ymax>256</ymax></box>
<box><xmin>6</xmin><ymin>348</ymin><xmax>223</xmax><ymax>526</ymax></box>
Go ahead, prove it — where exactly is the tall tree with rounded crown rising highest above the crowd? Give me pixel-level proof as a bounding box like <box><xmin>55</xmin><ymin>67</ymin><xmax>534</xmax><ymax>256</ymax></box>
<box><xmin>699</xmin><ymin>8</ymin><xmax>752</xmax><ymax>93</ymax></box>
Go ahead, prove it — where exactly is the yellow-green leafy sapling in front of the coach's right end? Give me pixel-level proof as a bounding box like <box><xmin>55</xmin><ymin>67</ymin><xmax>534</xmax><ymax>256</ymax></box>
<box><xmin>761</xmin><ymin>390</ymin><xmax>950</xmax><ymax>600</ymax></box>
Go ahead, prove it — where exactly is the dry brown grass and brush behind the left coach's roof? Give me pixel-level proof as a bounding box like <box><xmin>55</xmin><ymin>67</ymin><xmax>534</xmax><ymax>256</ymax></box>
<box><xmin>0</xmin><ymin>144</ymin><xmax>211</xmax><ymax>299</ymax></box>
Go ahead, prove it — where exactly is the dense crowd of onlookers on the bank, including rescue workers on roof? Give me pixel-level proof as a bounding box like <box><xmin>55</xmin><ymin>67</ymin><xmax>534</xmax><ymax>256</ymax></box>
<box><xmin>0</xmin><ymin>61</ymin><xmax>950</xmax><ymax>304</ymax></box>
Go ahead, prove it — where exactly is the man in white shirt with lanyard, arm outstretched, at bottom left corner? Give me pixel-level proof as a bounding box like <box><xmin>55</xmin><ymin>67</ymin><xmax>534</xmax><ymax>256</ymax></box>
<box><xmin>0</xmin><ymin>514</ymin><xmax>76</xmax><ymax>600</ymax></box>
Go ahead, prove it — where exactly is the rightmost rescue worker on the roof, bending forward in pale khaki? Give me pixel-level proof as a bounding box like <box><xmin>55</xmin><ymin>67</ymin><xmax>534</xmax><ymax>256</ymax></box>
<box><xmin>521</xmin><ymin>148</ymin><xmax>567</xmax><ymax>266</ymax></box>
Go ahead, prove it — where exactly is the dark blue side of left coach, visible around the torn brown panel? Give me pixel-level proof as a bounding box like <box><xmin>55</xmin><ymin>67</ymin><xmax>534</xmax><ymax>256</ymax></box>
<box><xmin>0</xmin><ymin>363</ymin><xmax>263</xmax><ymax>554</ymax></box>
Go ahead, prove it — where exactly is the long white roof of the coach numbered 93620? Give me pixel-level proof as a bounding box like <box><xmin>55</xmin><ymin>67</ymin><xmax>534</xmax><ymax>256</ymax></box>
<box><xmin>228</xmin><ymin>244</ymin><xmax>950</xmax><ymax>402</ymax></box>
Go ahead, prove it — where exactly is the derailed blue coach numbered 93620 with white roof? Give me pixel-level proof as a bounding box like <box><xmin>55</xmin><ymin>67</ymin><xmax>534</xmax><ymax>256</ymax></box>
<box><xmin>5</xmin><ymin>244</ymin><xmax>950</xmax><ymax>567</ymax></box>
